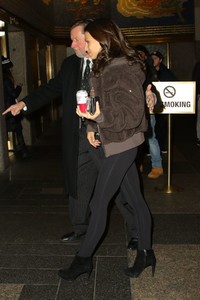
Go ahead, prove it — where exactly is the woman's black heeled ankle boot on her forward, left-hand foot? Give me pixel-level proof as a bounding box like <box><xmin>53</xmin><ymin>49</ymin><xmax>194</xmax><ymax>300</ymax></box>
<box><xmin>58</xmin><ymin>255</ymin><xmax>93</xmax><ymax>281</ymax></box>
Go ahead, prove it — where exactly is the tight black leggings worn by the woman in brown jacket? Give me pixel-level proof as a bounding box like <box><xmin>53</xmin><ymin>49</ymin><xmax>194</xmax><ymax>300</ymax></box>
<box><xmin>79</xmin><ymin>148</ymin><xmax>151</xmax><ymax>257</ymax></box>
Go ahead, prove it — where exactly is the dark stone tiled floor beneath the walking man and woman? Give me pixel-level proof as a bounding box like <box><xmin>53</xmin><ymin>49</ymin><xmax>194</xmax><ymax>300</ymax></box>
<box><xmin>0</xmin><ymin>115</ymin><xmax>200</xmax><ymax>300</ymax></box>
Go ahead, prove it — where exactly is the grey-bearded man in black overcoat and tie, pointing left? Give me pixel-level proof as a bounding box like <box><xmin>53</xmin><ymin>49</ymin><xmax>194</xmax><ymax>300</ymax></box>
<box><xmin>3</xmin><ymin>21</ymin><xmax>153</xmax><ymax>249</ymax></box>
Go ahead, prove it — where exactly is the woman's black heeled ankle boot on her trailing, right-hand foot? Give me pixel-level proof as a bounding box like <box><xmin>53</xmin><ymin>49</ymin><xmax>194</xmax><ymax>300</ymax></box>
<box><xmin>125</xmin><ymin>249</ymin><xmax>156</xmax><ymax>278</ymax></box>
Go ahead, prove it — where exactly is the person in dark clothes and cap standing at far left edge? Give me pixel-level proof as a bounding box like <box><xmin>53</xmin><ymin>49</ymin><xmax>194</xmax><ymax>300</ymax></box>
<box><xmin>1</xmin><ymin>56</ymin><xmax>30</xmax><ymax>158</ymax></box>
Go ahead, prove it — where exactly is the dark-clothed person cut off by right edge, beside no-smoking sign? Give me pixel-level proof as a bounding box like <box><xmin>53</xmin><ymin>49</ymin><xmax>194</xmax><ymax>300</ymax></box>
<box><xmin>192</xmin><ymin>61</ymin><xmax>200</xmax><ymax>147</ymax></box>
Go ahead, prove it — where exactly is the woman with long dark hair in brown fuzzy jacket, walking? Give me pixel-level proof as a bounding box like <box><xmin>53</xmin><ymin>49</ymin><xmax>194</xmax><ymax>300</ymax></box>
<box><xmin>59</xmin><ymin>19</ymin><xmax>156</xmax><ymax>281</ymax></box>
